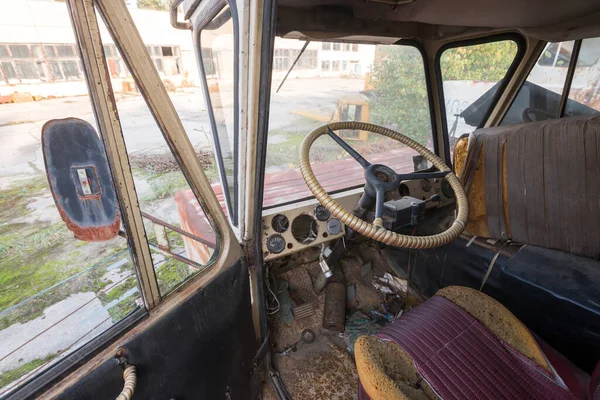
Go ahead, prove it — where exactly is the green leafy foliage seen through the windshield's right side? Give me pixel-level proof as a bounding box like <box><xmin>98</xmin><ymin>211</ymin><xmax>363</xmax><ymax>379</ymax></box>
<box><xmin>370</xmin><ymin>46</ymin><xmax>431</xmax><ymax>144</ymax></box>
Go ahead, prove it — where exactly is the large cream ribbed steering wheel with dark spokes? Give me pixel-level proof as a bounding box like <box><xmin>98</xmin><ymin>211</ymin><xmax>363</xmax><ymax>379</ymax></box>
<box><xmin>299</xmin><ymin>121</ymin><xmax>469</xmax><ymax>249</ymax></box>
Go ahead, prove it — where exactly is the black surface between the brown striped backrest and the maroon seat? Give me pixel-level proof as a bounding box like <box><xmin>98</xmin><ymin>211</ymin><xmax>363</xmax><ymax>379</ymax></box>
<box><xmin>385</xmin><ymin>239</ymin><xmax>600</xmax><ymax>372</ymax></box>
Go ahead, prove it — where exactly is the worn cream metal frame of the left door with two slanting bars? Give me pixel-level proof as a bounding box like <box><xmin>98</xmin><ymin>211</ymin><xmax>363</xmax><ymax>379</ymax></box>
<box><xmin>25</xmin><ymin>0</ymin><xmax>244</xmax><ymax>398</ymax></box>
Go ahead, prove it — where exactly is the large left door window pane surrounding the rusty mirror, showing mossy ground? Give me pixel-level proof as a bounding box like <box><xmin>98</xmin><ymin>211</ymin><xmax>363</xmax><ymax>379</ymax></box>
<box><xmin>0</xmin><ymin>38</ymin><xmax>139</xmax><ymax>398</ymax></box>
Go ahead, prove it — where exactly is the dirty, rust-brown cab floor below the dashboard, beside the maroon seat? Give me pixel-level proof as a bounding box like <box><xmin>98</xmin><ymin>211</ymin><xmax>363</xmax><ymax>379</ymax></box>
<box><xmin>263</xmin><ymin>244</ymin><xmax>389</xmax><ymax>400</ymax></box>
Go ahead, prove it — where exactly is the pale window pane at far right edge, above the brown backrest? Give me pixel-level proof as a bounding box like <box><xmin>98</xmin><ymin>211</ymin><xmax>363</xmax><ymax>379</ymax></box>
<box><xmin>565</xmin><ymin>38</ymin><xmax>600</xmax><ymax>116</ymax></box>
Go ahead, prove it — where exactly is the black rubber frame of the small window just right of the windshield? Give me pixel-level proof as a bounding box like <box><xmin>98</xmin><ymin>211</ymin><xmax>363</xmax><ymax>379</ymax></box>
<box><xmin>434</xmin><ymin>32</ymin><xmax>527</xmax><ymax>168</ymax></box>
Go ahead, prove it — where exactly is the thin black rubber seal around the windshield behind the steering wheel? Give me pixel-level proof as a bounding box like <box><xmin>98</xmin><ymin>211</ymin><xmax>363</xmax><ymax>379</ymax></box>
<box><xmin>256</xmin><ymin>39</ymin><xmax>438</xmax><ymax>211</ymax></box>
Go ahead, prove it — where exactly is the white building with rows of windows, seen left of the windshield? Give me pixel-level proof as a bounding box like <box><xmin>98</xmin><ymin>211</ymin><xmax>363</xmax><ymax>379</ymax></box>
<box><xmin>0</xmin><ymin>0</ymin><xmax>199</xmax><ymax>98</ymax></box>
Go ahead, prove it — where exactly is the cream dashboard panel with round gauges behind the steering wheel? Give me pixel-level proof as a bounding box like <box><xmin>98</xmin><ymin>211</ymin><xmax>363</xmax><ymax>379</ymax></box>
<box><xmin>262</xmin><ymin>178</ymin><xmax>454</xmax><ymax>261</ymax></box>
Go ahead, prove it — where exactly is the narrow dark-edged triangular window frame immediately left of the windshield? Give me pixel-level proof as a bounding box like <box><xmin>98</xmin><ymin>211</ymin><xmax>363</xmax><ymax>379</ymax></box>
<box><xmin>193</xmin><ymin>0</ymin><xmax>240</xmax><ymax>227</ymax></box>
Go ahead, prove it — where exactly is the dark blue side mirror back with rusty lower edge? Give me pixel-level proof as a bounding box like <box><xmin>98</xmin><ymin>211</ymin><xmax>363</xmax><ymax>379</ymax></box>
<box><xmin>42</xmin><ymin>118</ymin><xmax>121</xmax><ymax>242</ymax></box>
